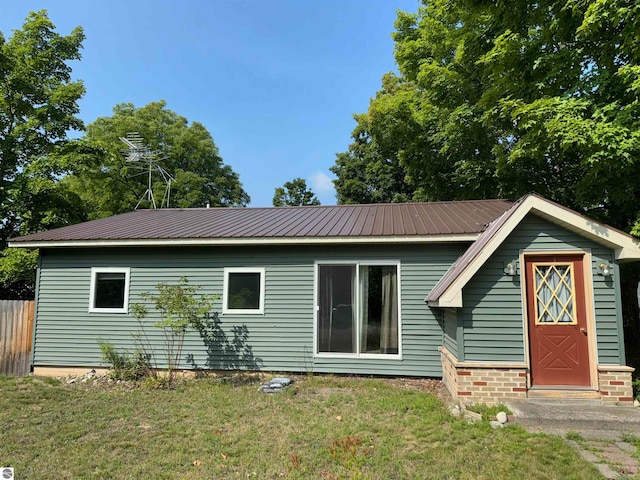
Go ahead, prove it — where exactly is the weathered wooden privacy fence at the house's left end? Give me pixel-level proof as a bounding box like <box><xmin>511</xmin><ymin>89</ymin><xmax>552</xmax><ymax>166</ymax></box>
<box><xmin>0</xmin><ymin>300</ymin><xmax>35</xmax><ymax>375</ymax></box>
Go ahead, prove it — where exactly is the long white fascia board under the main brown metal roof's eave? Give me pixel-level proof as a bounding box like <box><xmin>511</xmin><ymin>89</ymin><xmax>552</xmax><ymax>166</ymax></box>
<box><xmin>9</xmin><ymin>233</ymin><xmax>479</xmax><ymax>248</ymax></box>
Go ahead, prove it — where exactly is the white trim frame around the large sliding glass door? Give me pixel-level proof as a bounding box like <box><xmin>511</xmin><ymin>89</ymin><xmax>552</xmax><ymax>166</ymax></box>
<box><xmin>313</xmin><ymin>260</ymin><xmax>402</xmax><ymax>360</ymax></box>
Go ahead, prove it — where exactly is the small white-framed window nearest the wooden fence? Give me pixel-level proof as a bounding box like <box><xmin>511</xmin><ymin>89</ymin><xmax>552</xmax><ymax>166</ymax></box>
<box><xmin>89</xmin><ymin>267</ymin><xmax>131</xmax><ymax>313</ymax></box>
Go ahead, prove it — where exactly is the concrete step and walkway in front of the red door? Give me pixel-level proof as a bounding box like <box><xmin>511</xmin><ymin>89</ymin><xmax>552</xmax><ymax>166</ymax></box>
<box><xmin>507</xmin><ymin>399</ymin><xmax>640</xmax><ymax>479</ymax></box>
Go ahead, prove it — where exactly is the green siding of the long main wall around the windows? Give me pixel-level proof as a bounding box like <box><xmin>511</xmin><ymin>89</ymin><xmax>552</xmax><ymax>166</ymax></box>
<box><xmin>34</xmin><ymin>244</ymin><xmax>466</xmax><ymax>376</ymax></box>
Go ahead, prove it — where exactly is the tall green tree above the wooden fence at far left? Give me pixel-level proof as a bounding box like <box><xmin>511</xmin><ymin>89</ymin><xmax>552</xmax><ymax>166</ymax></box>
<box><xmin>0</xmin><ymin>10</ymin><xmax>86</xmax><ymax>296</ymax></box>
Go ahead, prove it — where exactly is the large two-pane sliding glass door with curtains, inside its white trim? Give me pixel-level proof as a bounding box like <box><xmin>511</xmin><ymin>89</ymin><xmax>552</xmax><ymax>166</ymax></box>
<box><xmin>316</xmin><ymin>262</ymin><xmax>400</xmax><ymax>356</ymax></box>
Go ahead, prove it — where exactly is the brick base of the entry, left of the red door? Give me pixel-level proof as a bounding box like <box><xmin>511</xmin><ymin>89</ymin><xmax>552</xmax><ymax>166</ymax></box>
<box><xmin>440</xmin><ymin>347</ymin><xmax>527</xmax><ymax>405</ymax></box>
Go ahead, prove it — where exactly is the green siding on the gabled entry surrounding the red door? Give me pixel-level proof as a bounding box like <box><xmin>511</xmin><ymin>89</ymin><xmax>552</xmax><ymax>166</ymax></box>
<box><xmin>458</xmin><ymin>214</ymin><xmax>623</xmax><ymax>365</ymax></box>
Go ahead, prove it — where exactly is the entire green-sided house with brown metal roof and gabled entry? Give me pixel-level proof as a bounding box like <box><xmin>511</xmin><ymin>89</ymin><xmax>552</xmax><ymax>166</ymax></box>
<box><xmin>10</xmin><ymin>194</ymin><xmax>640</xmax><ymax>403</ymax></box>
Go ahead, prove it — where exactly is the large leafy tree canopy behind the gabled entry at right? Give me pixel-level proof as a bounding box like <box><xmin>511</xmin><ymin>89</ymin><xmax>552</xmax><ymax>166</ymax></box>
<box><xmin>332</xmin><ymin>0</ymin><xmax>640</xmax><ymax>234</ymax></box>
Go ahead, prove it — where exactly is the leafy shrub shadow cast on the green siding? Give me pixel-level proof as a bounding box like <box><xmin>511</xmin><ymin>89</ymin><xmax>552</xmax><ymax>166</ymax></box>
<box><xmin>187</xmin><ymin>313</ymin><xmax>262</xmax><ymax>370</ymax></box>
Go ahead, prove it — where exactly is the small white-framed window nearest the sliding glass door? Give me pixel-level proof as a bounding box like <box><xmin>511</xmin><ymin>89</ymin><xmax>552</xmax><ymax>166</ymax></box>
<box><xmin>222</xmin><ymin>267</ymin><xmax>264</xmax><ymax>315</ymax></box>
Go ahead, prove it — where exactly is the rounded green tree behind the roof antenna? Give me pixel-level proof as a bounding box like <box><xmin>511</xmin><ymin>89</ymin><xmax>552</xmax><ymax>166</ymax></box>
<box><xmin>61</xmin><ymin>101</ymin><xmax>250</xmax><ymax>218</ymax></box>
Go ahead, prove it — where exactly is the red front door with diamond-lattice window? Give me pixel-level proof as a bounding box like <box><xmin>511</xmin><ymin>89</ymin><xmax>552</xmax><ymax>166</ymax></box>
<box><xmin>525</xmin><ymin>255</ymin><xmax>591</xmax><ymax>387</ymax></box>
